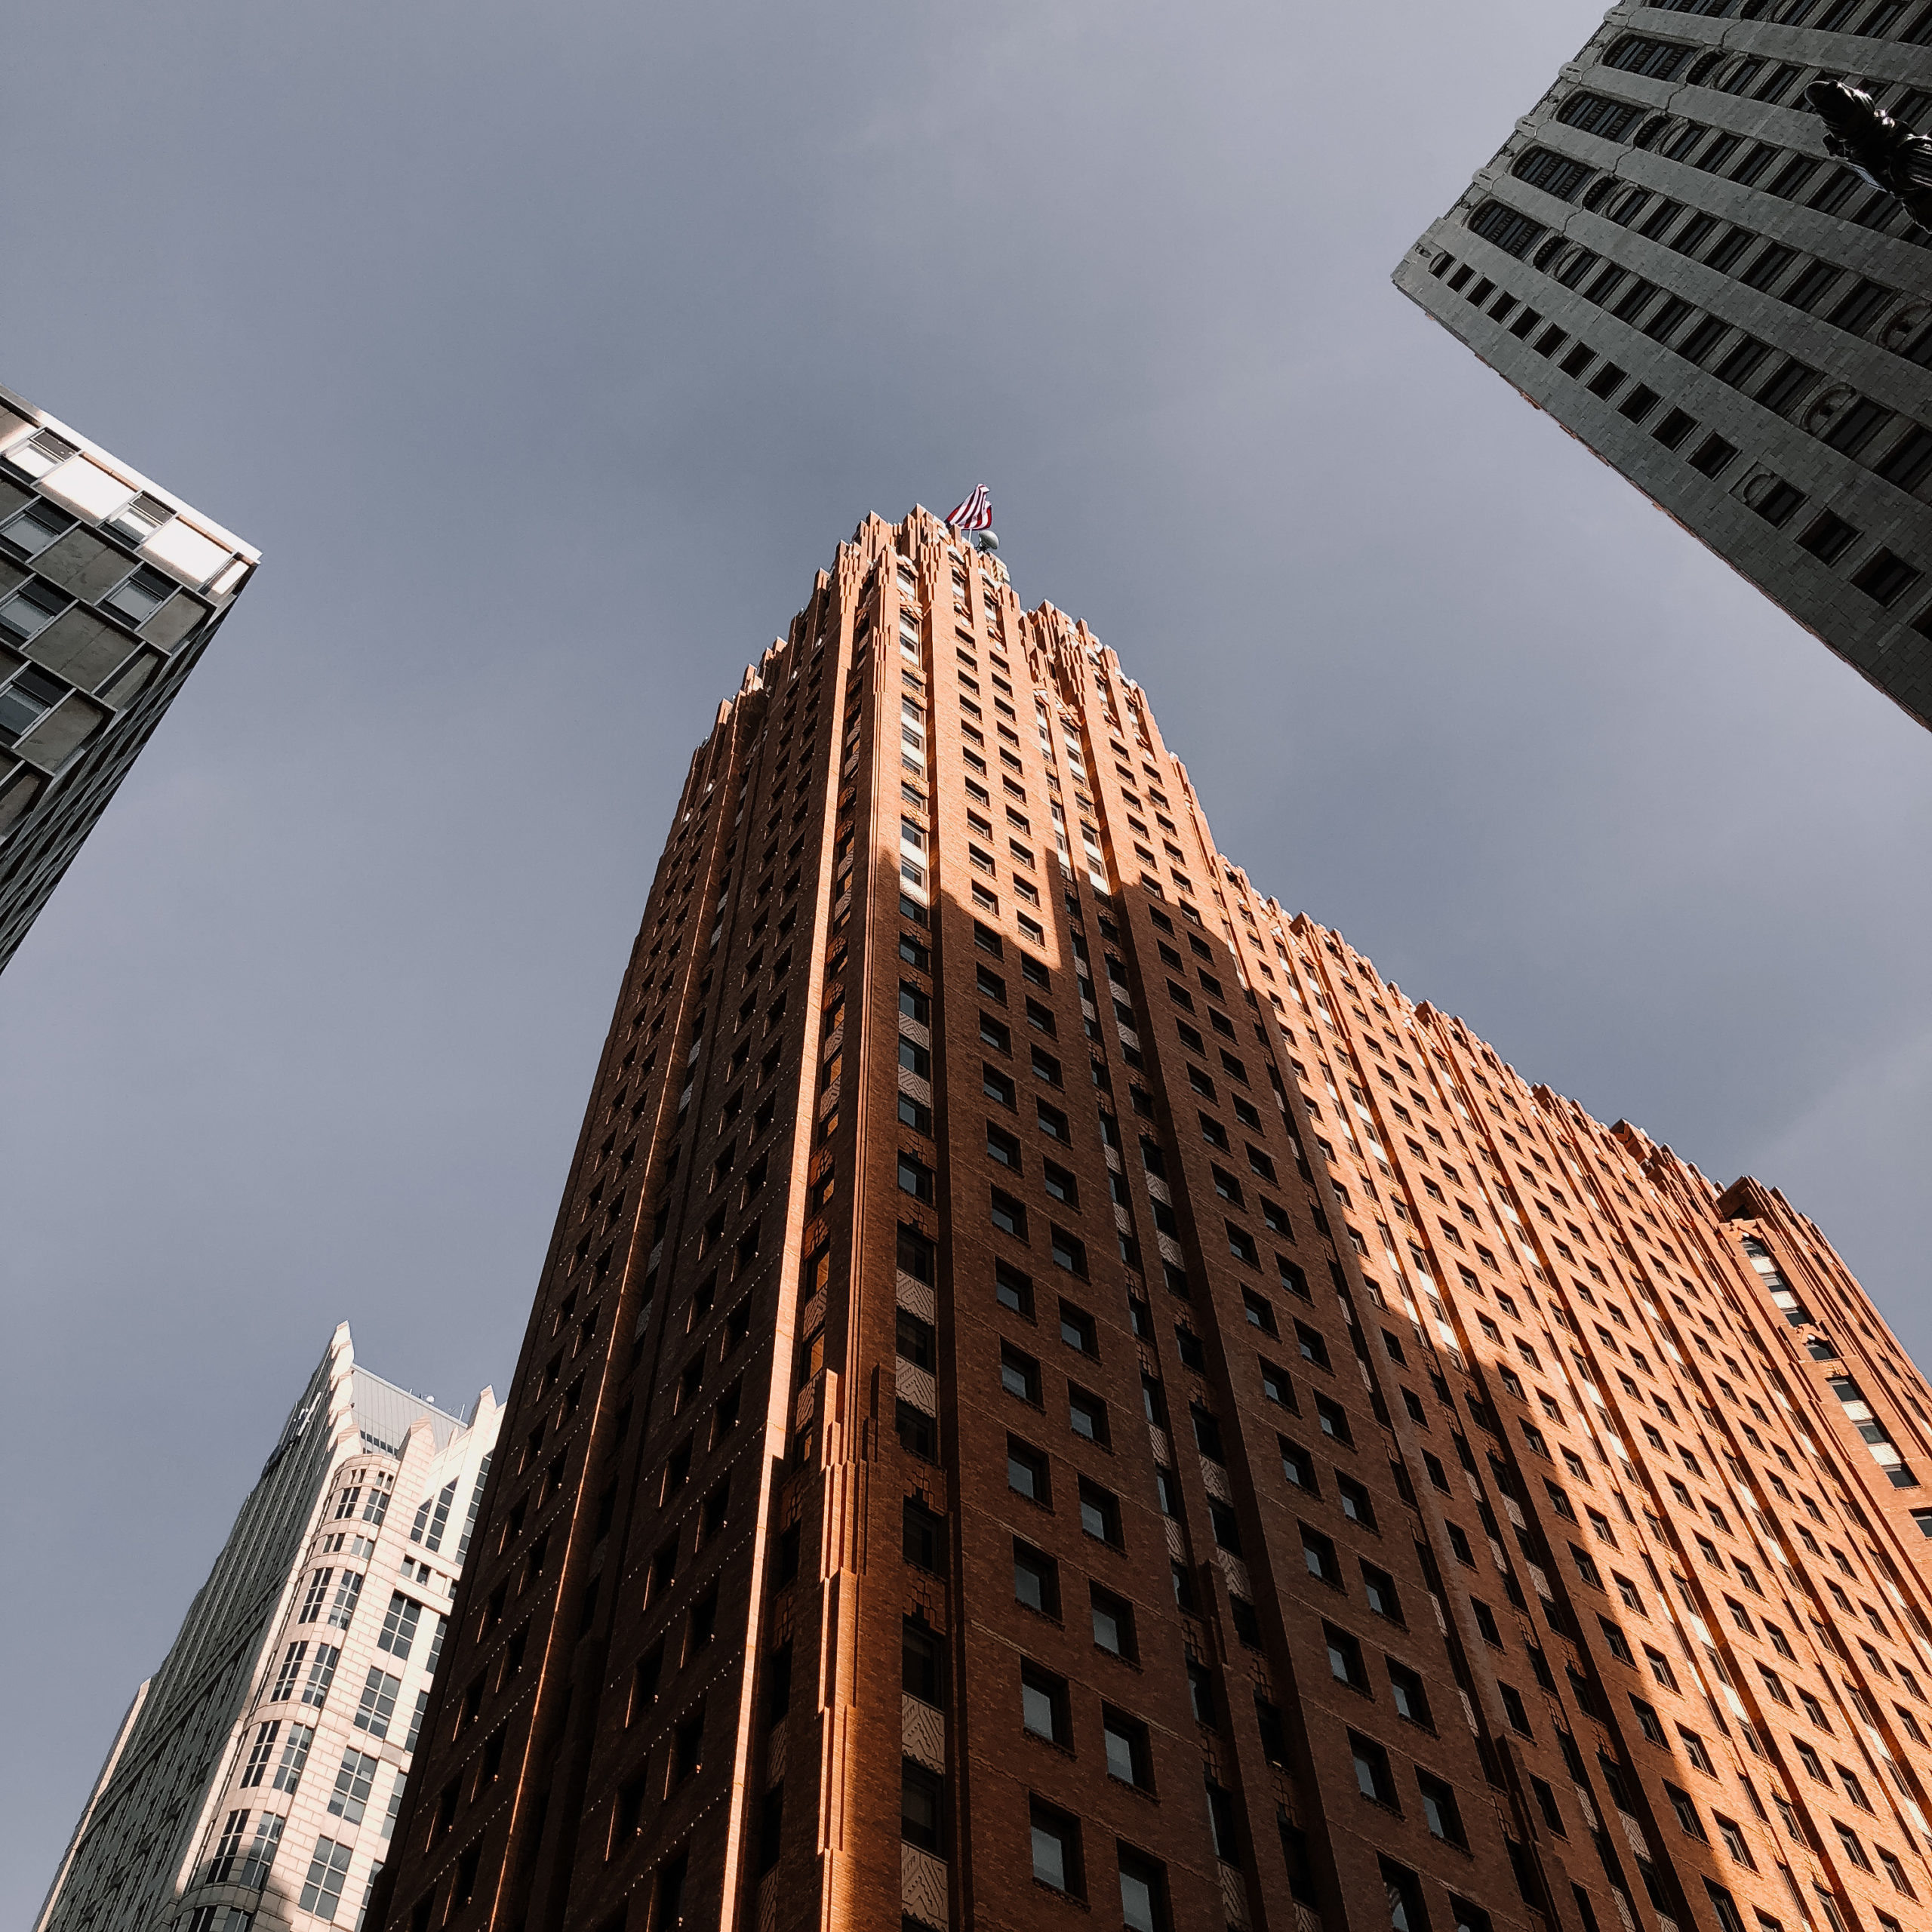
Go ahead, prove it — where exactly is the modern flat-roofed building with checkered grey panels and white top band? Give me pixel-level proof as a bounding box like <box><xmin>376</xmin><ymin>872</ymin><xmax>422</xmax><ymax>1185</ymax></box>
<box><xmin>0</xmin><ymin>389</ymin><xmax>259</xmax><ymax>968</ymax></box>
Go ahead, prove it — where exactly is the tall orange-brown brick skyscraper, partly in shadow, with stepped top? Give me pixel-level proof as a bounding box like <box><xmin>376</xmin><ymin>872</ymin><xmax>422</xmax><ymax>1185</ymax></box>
<box><xmin>369</xmin><ymin>512</ymin><xmax>1932</xmax><ymax>1932</ymax></box>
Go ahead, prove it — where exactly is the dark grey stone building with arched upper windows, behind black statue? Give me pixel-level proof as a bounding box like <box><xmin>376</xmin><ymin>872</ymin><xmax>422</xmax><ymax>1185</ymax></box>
<box><xmin>1395</xmin><ymin>0</ymin><xmax>1932</xmax><ymax>724</ymax></box>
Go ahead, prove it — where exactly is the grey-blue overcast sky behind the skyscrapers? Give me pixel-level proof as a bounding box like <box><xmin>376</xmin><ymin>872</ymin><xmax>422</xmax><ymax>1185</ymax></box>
<box><xmin>0</xmin><ymin>0</ymin><xmax>1932</xmax><ymax>1926</ymax></box>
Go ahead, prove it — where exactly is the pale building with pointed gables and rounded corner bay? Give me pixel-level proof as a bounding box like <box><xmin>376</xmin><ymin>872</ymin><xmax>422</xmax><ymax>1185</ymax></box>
<box><xmin>37</xmin><ymin>1324</ymin><xmax>500</xmax><ymax>1932</ymax></box>
